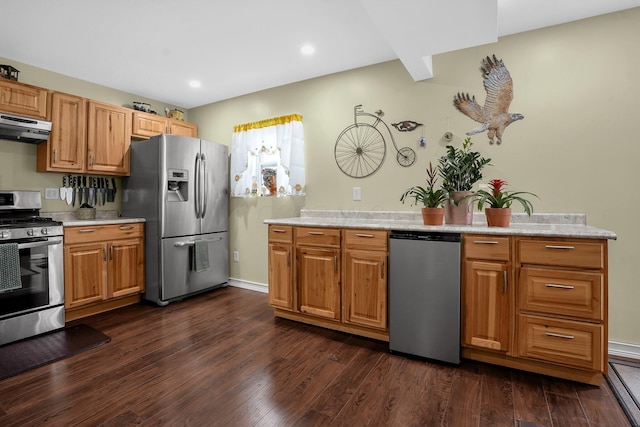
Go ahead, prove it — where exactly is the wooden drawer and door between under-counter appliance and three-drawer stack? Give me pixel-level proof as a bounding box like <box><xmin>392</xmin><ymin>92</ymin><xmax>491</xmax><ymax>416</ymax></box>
<box><xmin>462</xmin><ymin>234</ymin><xmax>514</xmax><ymax>353</ymax></box>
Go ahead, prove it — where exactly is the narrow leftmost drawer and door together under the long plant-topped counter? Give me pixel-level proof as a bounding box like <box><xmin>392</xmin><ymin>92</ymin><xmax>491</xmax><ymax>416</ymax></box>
<box><xmin>268</xmin><ymin>225</ymin><xmax>295</xmax><ymax>311</ymax></box>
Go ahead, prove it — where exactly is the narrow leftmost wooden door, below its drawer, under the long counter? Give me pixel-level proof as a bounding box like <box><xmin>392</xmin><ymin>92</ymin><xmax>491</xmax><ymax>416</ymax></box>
<box><xmin>269</xmin><ymin>243</ymin><xmax>293</xmax><ymax>310</ymax></box>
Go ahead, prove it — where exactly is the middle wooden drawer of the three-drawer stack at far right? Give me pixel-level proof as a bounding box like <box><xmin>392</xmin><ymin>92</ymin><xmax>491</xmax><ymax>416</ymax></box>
<box><xmin>518</xmin><ymin>267</ymin><xmax>604</xmax><ymax>321</ymax></box>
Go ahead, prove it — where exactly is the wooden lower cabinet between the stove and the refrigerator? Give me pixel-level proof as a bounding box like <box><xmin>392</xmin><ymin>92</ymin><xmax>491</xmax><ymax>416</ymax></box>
<box><xmin>64</xmin><ymin>223</ymin><xmax>145</xmax><ymax>321</ymax></box>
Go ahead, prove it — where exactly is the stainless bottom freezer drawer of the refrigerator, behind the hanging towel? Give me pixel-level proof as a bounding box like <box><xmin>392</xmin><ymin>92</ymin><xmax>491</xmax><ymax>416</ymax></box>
<box><xmin>158</xmin><ymin>232</ymin><xmax>229</xmax><ymax>302</ymax></box>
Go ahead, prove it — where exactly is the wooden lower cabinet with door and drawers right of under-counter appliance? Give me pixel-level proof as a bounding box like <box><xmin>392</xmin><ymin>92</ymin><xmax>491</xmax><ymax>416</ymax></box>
<box><xmin>462</xmin><ymin>235</ymin><xmax>608</xmax><ymax>385</ymax></box>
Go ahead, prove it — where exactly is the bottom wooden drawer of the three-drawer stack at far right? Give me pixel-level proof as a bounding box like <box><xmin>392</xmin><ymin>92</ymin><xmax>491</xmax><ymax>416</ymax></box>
<box><xmin>518</xmin><ymin>314</ymin><xmax>603</xmax><ymax>371</ymax></box>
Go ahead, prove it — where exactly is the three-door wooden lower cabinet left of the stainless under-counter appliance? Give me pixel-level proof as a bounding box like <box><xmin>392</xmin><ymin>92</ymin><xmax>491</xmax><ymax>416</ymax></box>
<box><xmin>269</xmin><ymin>224</ymin><xmax>389</xmax><ymax>341</ymax></box>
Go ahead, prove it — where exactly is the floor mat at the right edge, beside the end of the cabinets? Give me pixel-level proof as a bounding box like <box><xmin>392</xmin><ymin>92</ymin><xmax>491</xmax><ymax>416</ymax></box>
<box><xmin>607</xmin><ymin>359</ymin><xmax>640</xmax><ymax>426</ymax></box>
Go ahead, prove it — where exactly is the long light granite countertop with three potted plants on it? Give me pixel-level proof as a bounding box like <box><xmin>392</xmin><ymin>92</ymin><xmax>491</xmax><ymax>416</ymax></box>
<box><xmin>264</xmin><ymin>209</ymin><xmax>617</xmax><ymax>240</ymax></box>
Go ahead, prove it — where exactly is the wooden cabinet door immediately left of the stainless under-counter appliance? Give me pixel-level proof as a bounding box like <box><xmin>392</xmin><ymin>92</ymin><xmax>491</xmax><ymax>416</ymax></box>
<box><xmin>343</xmin><ymin>251</ymin><xmax>387</xmax><ymax>329</ymax></box>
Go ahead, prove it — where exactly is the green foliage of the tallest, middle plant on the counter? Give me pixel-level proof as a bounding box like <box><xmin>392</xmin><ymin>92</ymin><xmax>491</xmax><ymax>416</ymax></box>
<box><xmin>439</xmin><ymin>138</ymin><xmax>491</xmax><ymax>193</ymax></box>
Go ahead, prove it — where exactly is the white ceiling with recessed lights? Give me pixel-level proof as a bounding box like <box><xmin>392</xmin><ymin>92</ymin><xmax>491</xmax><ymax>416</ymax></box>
<box><xmin>0</xmin><ymin>0</ymin><xmax>640</xmax><ymax>108</ymax></box>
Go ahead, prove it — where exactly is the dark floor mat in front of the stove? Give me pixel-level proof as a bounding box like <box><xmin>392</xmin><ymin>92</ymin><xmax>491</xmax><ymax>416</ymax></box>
<box><xmin>0</xmin><ymin>325</ymin><xmax>111</xmax><ymax>381</ymax></box>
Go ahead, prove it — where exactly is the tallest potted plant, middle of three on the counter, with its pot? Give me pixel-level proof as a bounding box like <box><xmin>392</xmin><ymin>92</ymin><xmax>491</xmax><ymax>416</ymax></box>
<box><xmin>439</xmin><ymin>138</ymin><xmax>491</xmax><ymax>224</ymax></box>
